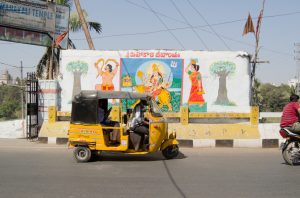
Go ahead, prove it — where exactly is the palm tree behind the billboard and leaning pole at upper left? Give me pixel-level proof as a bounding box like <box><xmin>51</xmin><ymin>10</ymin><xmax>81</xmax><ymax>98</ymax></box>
<box><xmin>36</xmin><ymin>0</ymin><xmax>102</xmax><ymax>79</ymax></box>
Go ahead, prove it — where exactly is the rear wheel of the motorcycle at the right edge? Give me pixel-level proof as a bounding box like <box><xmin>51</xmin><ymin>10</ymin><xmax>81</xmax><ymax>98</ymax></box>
<box><xmin>282</xmin><ymin>141</ymin><xmax>300</xmax><ymax>165</ymax></box>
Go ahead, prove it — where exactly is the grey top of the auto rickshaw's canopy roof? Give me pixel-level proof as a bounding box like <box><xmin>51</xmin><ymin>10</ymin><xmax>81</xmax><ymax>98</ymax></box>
<box><xmin>74</xmin><ymin>90</ymin><xmax>151</xmax><ymax>100</ymax></box>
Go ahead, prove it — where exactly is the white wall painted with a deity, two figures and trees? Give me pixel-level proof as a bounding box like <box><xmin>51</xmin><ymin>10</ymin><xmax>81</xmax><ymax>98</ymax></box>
<box><xmin>58</xmin><ymin>50</ymin><xmax>250</xmax><ymax>112</ymax></box>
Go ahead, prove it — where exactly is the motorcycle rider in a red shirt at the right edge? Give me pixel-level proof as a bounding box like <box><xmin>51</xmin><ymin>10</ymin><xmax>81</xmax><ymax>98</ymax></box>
<box><xmin>280</xmin><ymin>94</ymin><xmax>300</xmax><ymax>133</ymax></box>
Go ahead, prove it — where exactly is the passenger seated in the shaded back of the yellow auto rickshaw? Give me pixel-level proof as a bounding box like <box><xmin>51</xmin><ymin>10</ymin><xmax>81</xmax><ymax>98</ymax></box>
<box><xmin>98</xmin><ymin>100</ymin><xmax>120</xmax><ymax>145</ymax></box>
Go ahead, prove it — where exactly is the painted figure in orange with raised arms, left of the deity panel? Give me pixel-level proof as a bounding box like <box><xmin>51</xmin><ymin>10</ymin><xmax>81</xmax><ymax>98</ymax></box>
<box><xmin>95</xmin><ymin>58</ymin><xmax>119</xmax><ymax>91</ymax></box>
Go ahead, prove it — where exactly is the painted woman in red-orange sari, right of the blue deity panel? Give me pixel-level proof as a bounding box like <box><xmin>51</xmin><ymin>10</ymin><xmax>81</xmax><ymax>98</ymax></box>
<box><xmin>185</xmin><ymin>60</ymin><xmax>205</xmax><ymax>106</ymax></box>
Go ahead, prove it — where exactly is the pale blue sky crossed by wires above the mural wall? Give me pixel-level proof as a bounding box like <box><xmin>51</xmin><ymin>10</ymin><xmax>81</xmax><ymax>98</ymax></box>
<box><xmin>0</xmin><ymin>0</ymin><xmax>300</xmax><ymax>84</ymax></box>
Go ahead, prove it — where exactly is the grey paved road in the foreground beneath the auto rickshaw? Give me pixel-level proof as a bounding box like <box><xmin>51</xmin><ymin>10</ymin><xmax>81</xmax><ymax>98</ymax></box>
<box><xmin>0</xmin><ymin>139</ymin><xmax>300</xmax><ymax>198</ymax></box>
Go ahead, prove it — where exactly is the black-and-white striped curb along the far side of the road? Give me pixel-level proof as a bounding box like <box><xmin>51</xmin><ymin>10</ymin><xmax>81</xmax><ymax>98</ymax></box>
<box><xmin>38</xmin><ymin>137</ymin><xmax>282</xmax><ymax>148</ymax></box>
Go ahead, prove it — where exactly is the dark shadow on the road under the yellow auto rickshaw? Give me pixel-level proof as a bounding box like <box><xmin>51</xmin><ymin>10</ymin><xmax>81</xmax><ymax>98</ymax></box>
<box><xmin>90</xmin><ymin>151</ymin><xmax>187</xmax><ymax>162</ymax></box>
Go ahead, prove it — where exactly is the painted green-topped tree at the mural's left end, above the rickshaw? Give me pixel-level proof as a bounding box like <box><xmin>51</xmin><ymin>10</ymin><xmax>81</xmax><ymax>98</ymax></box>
<box><xmin>67</xmin><ymin>61</ymin><xmax>88</xmax><ymax>98</ymax></box>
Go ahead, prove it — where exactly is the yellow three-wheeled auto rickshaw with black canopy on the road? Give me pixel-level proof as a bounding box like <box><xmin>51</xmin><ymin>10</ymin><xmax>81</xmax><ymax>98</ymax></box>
<box><xmin>68</xmin><ymin>91</ymin><xmax>179</xmax><ymax>162</ymax></box>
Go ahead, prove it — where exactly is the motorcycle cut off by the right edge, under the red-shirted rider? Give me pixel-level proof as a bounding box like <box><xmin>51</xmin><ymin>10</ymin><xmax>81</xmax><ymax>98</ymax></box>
<box><xmin>279</xmin><ymin>128</ymin><xmax>300</xmax><ymax>166</ymax></box>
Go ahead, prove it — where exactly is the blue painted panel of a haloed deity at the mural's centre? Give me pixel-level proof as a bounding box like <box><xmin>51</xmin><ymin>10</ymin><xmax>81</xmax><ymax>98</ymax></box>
<box><xmin>122</xmin><ymin>59</ymin><xmax>182</xmax><ymax>111</ymax></box>
